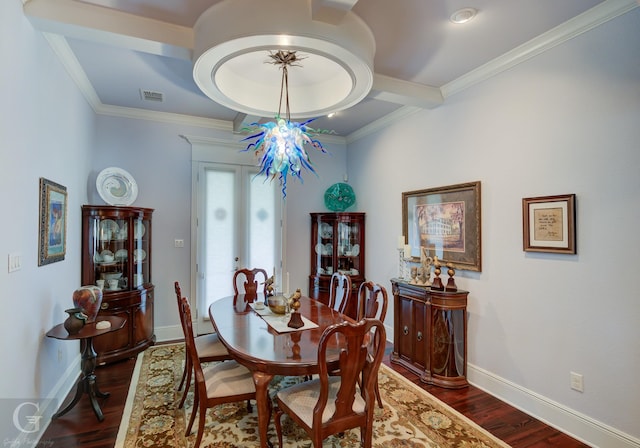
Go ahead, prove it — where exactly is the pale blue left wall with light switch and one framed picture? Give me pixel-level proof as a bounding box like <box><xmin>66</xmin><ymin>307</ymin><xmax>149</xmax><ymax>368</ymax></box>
<box><xmin>0</xmin><ymin>0</ymin><xmax>95</xmax><ymax>424</ymax></box>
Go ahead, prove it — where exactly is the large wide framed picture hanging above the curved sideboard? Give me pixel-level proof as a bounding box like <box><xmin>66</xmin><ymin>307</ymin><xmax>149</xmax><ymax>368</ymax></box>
<box><xmin>402</xmin><ymin>181</ymin><xmax>482</xmax><ymax>271</ymax></box>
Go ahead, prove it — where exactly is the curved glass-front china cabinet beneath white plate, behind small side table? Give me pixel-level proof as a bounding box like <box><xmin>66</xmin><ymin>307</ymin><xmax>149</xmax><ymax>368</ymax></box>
<box><xmin>82</xmin><ymin>205</ymin><xmax>155</xmax><ymax>364</ymax></box>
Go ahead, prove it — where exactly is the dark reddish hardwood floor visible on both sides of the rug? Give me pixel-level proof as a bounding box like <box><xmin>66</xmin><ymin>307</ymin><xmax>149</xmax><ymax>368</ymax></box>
<box><xmin>39</xmin><ymin>344</ymin><xmax>588</xmax><ymax>448</ymax></box>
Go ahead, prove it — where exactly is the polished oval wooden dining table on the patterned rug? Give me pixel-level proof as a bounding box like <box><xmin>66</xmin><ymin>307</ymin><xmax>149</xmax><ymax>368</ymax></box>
<box><xmin>209</xmin><ymin>294</ymin><xmax>353</xmax><ymax>448</ymax></box>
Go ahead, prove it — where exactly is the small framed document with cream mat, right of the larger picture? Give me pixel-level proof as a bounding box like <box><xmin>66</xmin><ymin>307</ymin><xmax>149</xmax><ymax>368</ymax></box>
<box><xmin>522</xmin><ymin>194</ymin><xmax>576</xmax><ymax>254</ymax></box>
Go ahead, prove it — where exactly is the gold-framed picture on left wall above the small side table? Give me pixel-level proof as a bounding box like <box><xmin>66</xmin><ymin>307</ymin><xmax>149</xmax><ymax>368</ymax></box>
<box><xmin>38</xmin><ymin>177</ymin><xmax>67</xmax><ymax>266</ymax></box>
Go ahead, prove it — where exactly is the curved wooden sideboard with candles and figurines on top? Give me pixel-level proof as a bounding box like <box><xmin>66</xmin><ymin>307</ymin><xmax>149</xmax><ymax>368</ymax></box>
<box><xmin>391</xmin><ymin>279</ymin><xmax>469</xmax><ymax>389</ymax></box>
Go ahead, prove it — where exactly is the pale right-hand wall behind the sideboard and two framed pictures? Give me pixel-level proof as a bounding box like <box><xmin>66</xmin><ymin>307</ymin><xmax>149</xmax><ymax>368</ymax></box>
<box><xmin>348</xmin><ymin>9</ymin><xmax>640</xmax><ymax>446</ymax></box>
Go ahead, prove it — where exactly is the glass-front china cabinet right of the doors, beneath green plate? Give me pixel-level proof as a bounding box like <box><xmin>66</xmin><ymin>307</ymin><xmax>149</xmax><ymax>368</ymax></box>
<box><xmin>309</xmin><ymin>212</ymin><xmax>365</xmax><ymax>317</ymax></box>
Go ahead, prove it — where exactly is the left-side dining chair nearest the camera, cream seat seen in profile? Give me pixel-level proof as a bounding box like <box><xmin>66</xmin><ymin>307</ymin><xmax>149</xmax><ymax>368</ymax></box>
<box><xmin>181</xmin><ymin>297</ymin><xmax>256</xmax><ymax>448</ymax></box>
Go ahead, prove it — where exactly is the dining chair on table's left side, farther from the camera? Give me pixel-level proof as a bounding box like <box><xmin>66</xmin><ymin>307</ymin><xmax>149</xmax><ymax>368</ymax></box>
<box><xmin>173</xmin><ymin>282</ymin><xmax>232</xmax><ymax>409</ymax></box>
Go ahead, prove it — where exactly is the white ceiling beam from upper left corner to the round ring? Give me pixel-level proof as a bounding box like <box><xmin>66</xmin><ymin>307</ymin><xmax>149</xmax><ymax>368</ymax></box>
<box><xmin>23</xmin><ymin>0</ymin><xmax>193</xmax><ymax>60</ymax></box>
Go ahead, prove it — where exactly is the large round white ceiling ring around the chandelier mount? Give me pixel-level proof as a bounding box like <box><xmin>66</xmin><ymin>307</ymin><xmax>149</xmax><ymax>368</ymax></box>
<box><xmin>193</xmin><ymin>0</ymin><xmax>375</xmax><ymax>118</ymax></box>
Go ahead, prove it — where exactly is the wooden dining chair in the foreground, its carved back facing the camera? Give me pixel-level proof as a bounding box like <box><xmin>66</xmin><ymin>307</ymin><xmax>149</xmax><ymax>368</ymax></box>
<box><xmin>274</xmin><ymin>319</ymin><xmax>385</xmax><ymax>448</ymax></box>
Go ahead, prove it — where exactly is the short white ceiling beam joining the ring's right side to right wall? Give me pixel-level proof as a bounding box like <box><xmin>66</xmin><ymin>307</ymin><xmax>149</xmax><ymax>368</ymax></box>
<box><xmin>367</xmin><ymin>73</ymin><xmax>444</xmax><ymax>109</ymax></box>
